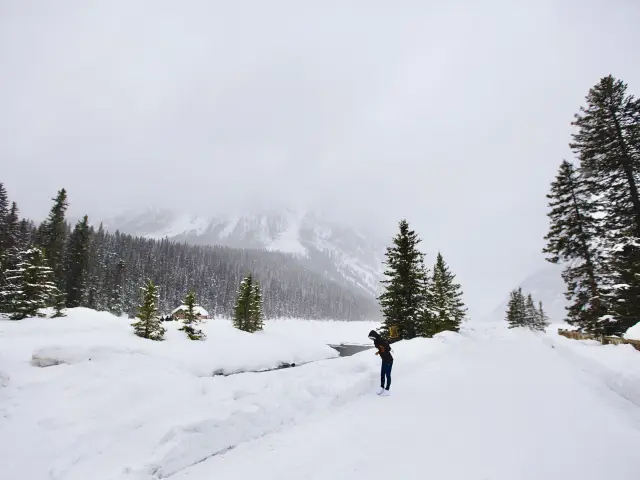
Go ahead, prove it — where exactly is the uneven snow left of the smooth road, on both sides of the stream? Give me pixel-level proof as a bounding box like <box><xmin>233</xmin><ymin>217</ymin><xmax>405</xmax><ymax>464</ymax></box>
<box><xmin>0</xmin><ymin>309</ymin><xmax>464</xmax><ymax>480</ymax></box>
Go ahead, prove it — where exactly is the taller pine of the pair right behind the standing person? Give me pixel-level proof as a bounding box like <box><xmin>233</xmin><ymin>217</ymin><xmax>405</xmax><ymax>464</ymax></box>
<box><xmin>378</xmin><ymin>220</ymin><xmax>426</xmax><ymax>339</ymax></box>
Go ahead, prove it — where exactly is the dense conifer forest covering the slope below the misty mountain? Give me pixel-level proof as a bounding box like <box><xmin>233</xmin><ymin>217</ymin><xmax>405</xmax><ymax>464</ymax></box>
<box><xmin>68</xmin><ymin>227</ymin><xmax>375</xmax><ymax>320</ymax></box>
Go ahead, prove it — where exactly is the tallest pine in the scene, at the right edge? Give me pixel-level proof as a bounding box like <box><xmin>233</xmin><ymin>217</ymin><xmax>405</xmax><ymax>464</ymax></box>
<box><xmin>571</xmin><ymin>75</ymin><xmax>640</xmax><ymax>334</ymax></box>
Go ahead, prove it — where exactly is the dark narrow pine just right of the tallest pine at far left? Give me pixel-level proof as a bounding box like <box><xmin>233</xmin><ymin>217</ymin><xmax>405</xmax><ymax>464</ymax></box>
<box><xmin>64</xmin><ymin>215</ymin><xmax>91</xmax><ymax>308</ymax></box>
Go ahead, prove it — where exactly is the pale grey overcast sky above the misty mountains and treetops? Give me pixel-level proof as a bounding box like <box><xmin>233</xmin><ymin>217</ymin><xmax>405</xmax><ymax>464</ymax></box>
<box><xmin>0</xmin><ymin>0</ymin><xmax>640</xmax><ymax>314</ymax></box>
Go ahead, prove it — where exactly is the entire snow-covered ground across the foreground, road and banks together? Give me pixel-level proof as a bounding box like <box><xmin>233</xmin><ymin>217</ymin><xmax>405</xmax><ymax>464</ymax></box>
<box><xmin>0</xmin><ymin>311</ymin><xmax>640</xmax><ymax>480</ymax></box>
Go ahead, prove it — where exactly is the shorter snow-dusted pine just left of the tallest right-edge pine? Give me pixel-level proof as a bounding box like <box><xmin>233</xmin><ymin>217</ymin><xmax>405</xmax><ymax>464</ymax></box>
<box><xmin>543</xmin><ymin>160</ymin><xmax>607</xmax><ymax>331</ymax></box>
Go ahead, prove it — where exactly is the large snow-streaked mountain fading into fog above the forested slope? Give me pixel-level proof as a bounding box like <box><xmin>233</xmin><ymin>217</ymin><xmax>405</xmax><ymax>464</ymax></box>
<box><xmin>104</xmin><ymin>209</ymin><xmax>385</xmax><ymax>295</ymax></box>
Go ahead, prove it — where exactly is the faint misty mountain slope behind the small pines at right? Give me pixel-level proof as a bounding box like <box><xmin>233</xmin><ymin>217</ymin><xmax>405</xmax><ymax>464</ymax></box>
<box><xmin>486</xmin><ymin>264</ymin><xmax>567</xmax><ymax>323</ymax></box>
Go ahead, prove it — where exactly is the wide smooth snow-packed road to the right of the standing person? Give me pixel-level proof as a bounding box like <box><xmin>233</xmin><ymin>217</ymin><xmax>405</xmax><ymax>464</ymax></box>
<box><xmin>172</xmin><ymin>326</ymin><xmax>640</xmax><ymax>480</ymax></box>
